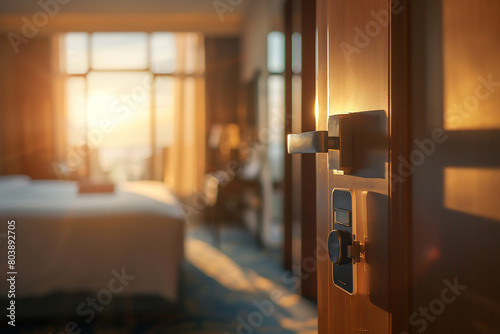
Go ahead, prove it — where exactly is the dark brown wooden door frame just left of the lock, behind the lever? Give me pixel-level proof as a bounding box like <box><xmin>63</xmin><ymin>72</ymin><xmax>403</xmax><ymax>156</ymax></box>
<box><xmin>284</xmin><ymin>0</ymin><xmax>317</xmax><ymax>301</ymax></box>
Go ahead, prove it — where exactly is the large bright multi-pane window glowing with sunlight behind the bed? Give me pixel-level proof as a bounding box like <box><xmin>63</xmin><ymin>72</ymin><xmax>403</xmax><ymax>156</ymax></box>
<box><xmin>61</xmin><ymin>32</ymin><xmax>204</xmax><ymax>182</ymax></box>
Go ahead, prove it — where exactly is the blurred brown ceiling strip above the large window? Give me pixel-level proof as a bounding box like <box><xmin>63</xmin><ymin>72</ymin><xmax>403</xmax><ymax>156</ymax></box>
<box><xmin>0</xmin><ymin>0</ymin><xmax>258</xmax><ymax>35</ymax></box>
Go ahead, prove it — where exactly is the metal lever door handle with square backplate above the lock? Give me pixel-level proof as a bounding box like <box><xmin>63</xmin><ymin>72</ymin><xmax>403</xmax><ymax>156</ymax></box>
<box><xmin>287</xmin><ymin>114</ymin><xmax>352</xmax><ymax>173</ymax></box>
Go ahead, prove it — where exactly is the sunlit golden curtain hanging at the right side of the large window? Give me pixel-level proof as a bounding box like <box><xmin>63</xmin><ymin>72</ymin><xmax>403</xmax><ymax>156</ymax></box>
<box><xmin>164</xmin><ymin>33</ymin><xmax>205</xmax><ymax>198</ymax></box>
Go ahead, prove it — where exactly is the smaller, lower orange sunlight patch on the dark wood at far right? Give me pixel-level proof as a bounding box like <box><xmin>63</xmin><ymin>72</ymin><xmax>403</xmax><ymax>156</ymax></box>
<box><xmin>444</xmin><ymin>167</ymin><xmax>500</xmax><ymax>221</ymax></box>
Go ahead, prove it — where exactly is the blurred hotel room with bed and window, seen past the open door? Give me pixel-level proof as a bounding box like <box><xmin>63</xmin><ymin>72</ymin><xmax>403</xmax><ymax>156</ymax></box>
<box><xmin>0</xmin><ymin>0</ymin><xmax>317</xmax><ymax>333</ymax></box>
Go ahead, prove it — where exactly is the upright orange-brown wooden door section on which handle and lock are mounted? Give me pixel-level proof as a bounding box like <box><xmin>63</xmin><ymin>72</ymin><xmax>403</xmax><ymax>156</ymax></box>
<box><xmin>316</xmin><ymin>0</ymin><xmax>407</xmax><ymax>334</ymax></box>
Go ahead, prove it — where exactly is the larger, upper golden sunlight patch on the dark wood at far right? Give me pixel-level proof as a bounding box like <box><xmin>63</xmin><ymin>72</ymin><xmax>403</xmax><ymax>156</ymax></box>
<box><xmin>442</xmin><ymin>0</ymin><xmax>500</xmax><ymax>131</ymax></box>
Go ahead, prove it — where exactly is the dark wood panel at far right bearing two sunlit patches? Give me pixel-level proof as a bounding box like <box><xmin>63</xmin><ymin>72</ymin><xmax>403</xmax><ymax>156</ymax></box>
<box><xmin>410</xmin><ymin>0</ymin><xmax>500</xmax><ymax>334</ymax></box>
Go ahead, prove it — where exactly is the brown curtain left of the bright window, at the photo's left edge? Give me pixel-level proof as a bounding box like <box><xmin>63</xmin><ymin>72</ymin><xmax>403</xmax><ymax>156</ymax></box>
<box><xmin>0</xmin><ymin>35</ymin><xmax>57</xmax><ymax>179</ymax></box>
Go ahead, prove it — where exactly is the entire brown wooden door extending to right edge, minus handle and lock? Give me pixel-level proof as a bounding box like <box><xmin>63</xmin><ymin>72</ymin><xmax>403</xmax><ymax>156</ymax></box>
<box><xmin>316</xmin><ymin>0</ymin><xmax>500</xmax><ymax>334</ymax></box>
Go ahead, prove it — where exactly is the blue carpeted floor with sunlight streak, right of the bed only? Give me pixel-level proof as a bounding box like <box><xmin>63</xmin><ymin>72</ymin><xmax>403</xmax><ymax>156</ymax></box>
<box><xmin>176</xmin><ymin>227</ymin><xmax>317</xmax><ymax>334</ymax></box>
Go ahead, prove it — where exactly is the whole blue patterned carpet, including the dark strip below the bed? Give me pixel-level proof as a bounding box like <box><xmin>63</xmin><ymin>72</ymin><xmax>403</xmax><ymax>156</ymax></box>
<box><xmin>0</xmin><ymin>227</ymin><xmax>317</xmax><ymax>334</ymax></box>
